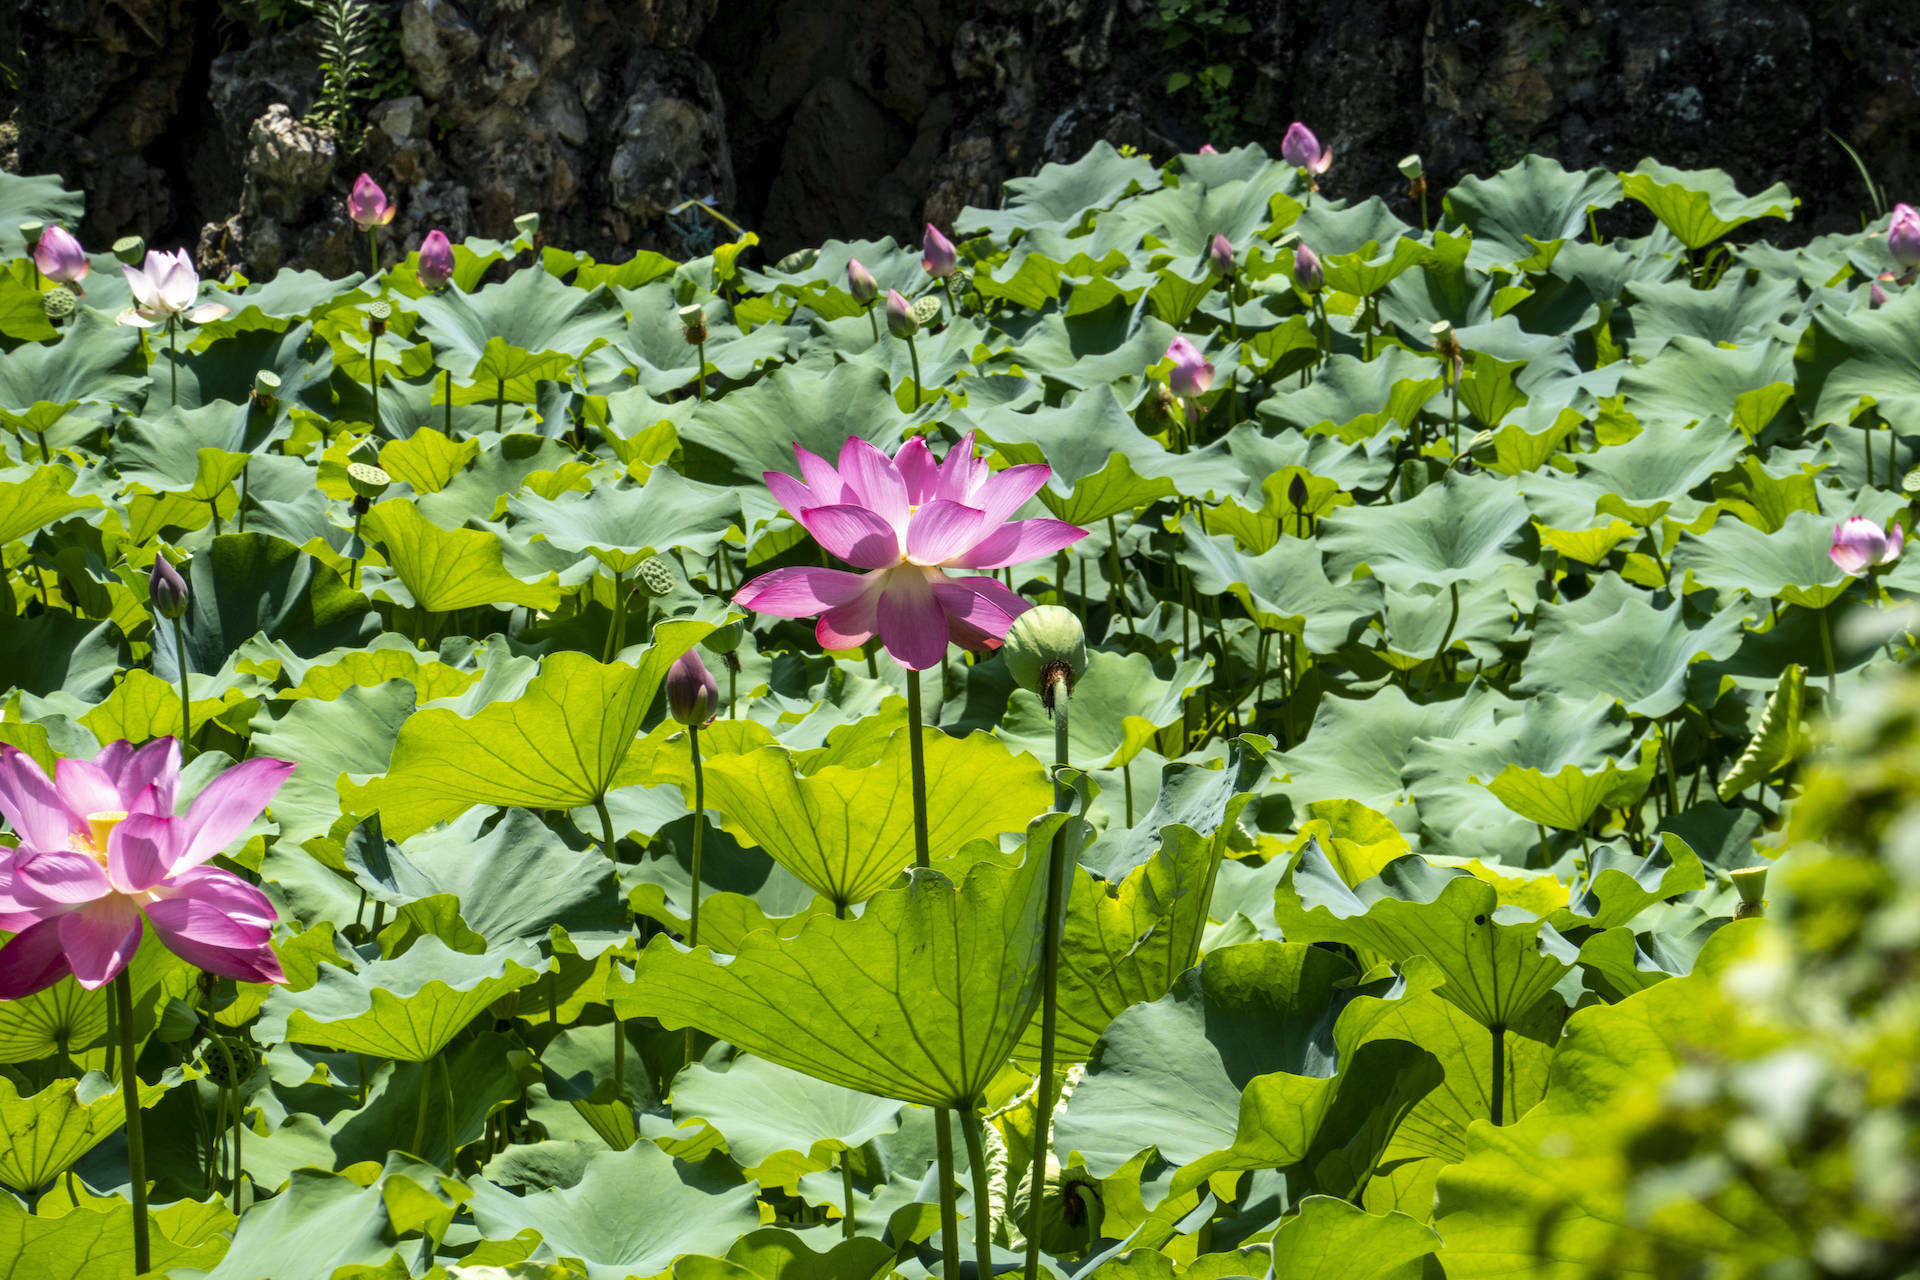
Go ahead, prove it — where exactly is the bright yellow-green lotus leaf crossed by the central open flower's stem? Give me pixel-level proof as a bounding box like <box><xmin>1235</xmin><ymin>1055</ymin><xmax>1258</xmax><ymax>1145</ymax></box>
<box><xmin>655</xmin><ymin>721</ymin><xmax>1052</xmax><ymax>906</ymax></box>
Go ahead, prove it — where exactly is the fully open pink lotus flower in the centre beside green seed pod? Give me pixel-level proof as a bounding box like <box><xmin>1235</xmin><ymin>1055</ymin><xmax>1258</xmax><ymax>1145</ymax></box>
<box><xmin>733</xmin><ymin>432</ymin><xmax>1087</xmax><ymax>672</ymax></box>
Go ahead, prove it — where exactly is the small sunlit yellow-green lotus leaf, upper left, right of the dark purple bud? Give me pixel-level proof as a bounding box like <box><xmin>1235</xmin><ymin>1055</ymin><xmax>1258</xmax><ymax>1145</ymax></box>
<box><xmin>363</xmin><ymin>497</ymin><xmax>561</xmax><ymax>614</ymax></box>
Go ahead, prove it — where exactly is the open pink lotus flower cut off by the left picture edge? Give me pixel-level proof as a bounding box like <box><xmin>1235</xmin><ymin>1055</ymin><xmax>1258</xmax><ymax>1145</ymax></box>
<box><xmin>0</xmin><ymin>737</ymin><xmax>294</xmax><ymax>1000</ymax></box>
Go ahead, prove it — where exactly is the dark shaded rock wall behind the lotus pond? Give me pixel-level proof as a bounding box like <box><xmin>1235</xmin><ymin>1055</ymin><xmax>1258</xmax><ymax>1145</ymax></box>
<box><xmin>0</xmin><ymin>0</ymin><xmax>1920</xmax><ymax>276</ymax></box>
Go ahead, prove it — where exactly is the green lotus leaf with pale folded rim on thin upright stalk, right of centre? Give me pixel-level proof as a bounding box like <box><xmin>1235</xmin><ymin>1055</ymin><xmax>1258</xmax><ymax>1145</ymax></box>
<box><xmin>1273</xmin><ymin>842</ymin><xmax>1578</xmax><ymax>1027</ymax></box>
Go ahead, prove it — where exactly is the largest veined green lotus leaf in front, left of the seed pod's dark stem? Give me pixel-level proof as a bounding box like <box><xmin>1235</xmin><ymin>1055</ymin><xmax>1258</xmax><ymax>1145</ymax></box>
<box><xmin>612</xmin><ymin>814</ymin><xmax>1068</xmax><ymax>1107</ymax></box>
